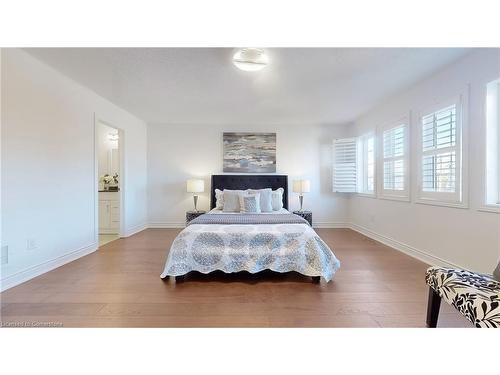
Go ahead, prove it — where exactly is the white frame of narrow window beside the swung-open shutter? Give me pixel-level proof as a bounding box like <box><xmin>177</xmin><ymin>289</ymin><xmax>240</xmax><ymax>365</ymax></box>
<box><xmin>357</xmin><ymin>131</ymin><xmax>378</xmax><ymax>198</ymax></box>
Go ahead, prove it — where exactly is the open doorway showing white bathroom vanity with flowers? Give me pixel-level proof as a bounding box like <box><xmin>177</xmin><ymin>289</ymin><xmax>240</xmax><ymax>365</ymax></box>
<box><xmin>95</xmin><ymin>119</ymin><xmax>123</xmax><ymax>248</ymax></box>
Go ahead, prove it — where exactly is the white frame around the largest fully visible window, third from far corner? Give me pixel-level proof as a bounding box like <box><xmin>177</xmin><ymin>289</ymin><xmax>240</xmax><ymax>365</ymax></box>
<box><xmin>414</xmin><ymin>90</ymin><xmax>468</xmax><ymax>208</ymax></box>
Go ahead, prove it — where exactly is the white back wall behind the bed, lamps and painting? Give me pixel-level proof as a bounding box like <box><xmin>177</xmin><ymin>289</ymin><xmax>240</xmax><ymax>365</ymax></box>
<box><xmin>148</xmin><ymin>124</ymin><xmax>347</xmax><ymax>227</ymax></box>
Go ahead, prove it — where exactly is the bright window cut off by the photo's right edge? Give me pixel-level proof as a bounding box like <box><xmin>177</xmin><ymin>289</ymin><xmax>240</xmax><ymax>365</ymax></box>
<box><xmin>485</xmin><ymin>79</ymin><xmax>500</xmax><ymax>209</ymax></box>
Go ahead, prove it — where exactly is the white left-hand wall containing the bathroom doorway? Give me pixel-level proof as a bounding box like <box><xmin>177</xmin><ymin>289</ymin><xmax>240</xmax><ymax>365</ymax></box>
<box><xmin>1</xmin><ymin>49</ymin><xmax>147</xmax><ymax>289</ymax></box>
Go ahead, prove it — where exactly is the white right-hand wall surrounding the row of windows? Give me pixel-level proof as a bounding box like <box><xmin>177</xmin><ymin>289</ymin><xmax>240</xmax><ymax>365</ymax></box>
<box><xmin>349</xmin><ymin>50</ymin><xmax>500</xmax><ymax>273</ymax></box>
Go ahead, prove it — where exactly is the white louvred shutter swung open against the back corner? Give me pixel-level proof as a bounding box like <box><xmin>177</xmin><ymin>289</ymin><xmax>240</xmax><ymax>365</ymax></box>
<box><xmin>333</xmin><ymin>138</ymin><xmax>357</xmax><ymax>193</ymax></box>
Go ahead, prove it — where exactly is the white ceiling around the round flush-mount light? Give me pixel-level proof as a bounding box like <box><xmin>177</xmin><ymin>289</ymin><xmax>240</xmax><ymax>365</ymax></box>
<box><xmin>27</xmin><ymin>48</ymin><xmax>469</xmax><ymax>124</ymax></box>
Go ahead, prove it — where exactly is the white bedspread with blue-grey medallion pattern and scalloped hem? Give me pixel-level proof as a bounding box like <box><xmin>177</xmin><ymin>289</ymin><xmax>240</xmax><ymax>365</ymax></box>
<box><xmin>161</xmin><ymin>224</ymin><xmax>340</xmax><ymax>281</ymax></box>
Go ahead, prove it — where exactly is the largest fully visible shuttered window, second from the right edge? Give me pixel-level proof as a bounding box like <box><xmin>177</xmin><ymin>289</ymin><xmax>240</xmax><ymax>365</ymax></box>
<box><xmin>419</xmin><ymin>100</ymin><xmax>462</xmax><ymax>205</ymax></box>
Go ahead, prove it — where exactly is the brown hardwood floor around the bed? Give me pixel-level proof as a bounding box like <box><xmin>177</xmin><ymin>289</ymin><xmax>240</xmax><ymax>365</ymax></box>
<box><xmin>0</xmin><ymin>229</ymin><xmax>470</xmax><ymax>327</ymax></box>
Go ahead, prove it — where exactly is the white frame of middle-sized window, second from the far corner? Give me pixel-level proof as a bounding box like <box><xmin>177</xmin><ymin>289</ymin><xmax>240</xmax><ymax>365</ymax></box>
<box><xmin>378</xmin><ymin>113</ymin><xmax>412</xmax><ymax>202</ymax></box>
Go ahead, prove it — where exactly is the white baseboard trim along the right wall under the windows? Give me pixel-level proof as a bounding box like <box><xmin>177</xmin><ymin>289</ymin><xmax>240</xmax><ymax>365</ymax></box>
<box><xmin>350</xmin><ymin>223</ymin><xmax>463</xmax><ymax>268</ymax></box>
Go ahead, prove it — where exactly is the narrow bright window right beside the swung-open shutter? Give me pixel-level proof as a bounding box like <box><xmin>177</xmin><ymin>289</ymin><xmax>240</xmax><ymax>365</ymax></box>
<box><xmin>358</xmin><ymin>134</ymin><xmax>375</xmax><ymax>195</ymax></box>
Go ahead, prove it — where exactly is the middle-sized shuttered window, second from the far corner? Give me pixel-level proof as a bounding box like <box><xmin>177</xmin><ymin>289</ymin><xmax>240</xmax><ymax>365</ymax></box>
<box><xmin>380</xmin><ymin>122</ymin><xmax>409</xmax><ymax>199</ymax></box>
